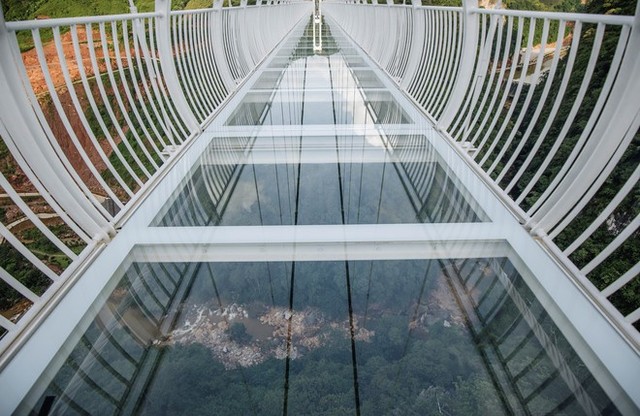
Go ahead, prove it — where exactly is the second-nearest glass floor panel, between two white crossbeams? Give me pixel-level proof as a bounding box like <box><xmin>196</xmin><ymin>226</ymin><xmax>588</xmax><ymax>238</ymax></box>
<box><xmin>155</xmin><ymin>136</ymin><xmax>484</xmax><ymax>226</ymax></box>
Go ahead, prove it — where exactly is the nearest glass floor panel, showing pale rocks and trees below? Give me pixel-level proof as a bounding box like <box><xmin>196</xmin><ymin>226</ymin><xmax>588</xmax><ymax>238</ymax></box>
<box><xmin>28</xmin><ymin>258</ymin><xmax>618</xmax><ymax>415</ymax></box>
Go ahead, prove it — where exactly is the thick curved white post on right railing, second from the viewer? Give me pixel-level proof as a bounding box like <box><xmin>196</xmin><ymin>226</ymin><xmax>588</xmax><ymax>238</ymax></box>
<box><xmin>437</xmin><ymin>0</ymin><xmax>480</xmax><ymax>131</ymax></box>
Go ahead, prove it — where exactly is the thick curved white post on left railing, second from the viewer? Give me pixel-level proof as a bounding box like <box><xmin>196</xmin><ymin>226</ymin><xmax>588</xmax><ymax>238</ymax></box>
<box><xmin>156</xmin><ymin>0</ymin><xmax>202</xmax><ymax>133</ymax></box>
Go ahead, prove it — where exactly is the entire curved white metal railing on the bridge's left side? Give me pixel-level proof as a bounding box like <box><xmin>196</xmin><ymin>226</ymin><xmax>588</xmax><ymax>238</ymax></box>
<box><xmin>0</xmin><ymin>0</ymin><xmax>311</xmax><ymax>359</ymax></box>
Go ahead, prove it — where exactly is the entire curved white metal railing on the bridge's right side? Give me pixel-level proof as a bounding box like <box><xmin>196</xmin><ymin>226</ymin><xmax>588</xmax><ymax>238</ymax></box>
<box><xmin>323</xmin><ymin>0</ymin><xmax>640</xmax><ymax>347</ymax></box>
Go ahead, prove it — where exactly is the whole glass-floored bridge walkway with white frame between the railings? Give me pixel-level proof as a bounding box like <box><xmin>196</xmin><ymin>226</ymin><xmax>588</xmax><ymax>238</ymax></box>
<box><xmin>5</xmin><ymin>14</ymin><xmax>633</xmax><ymax>415</ymax></box>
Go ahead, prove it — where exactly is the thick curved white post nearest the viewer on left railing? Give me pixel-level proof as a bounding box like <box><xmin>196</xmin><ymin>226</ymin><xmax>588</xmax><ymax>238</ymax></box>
<box><xmin>0</xmin><ymin>5</ymin><xmax>115</xmax><ymax>241</ymax></box>
